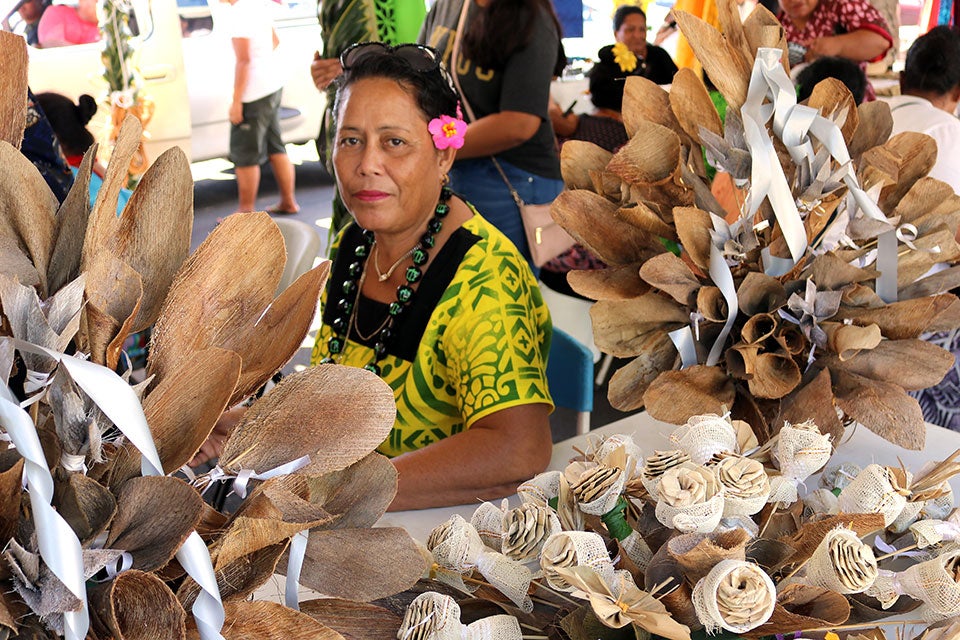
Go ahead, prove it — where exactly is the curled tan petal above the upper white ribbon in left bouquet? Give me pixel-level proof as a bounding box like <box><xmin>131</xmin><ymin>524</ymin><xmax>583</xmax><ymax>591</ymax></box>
<box><xmin>77</xmin><ymin>251</ymin><xmax>144</xmax><ymax>369</ymax></box>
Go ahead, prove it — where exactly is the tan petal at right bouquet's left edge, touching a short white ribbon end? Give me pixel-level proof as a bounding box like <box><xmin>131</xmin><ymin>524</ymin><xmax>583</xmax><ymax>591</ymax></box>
<box><xmin>590</xmin><ymin>293</ymin><xmax>690</xmax><ymax>358</ymax></box>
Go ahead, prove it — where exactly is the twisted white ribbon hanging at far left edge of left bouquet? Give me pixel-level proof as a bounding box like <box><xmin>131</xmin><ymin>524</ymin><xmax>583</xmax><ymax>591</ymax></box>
<box><xmin>0</xmin><ymin>383</ymin><xmax>90</xmax><ymax>640</ymax></box>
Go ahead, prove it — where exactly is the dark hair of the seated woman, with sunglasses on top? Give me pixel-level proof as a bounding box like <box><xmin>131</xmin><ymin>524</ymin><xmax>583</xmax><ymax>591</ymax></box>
<box><xmin>333</xmin><ymin>50</ymin><xmax>458</xmax><ymax>121</ymax></box>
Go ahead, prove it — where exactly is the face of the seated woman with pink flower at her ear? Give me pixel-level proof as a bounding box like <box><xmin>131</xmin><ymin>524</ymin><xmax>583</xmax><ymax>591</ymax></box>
<box><xmin>333</xmin><ymin>78</ymin><xmax>455</xmax><ymax>241</ymax></box>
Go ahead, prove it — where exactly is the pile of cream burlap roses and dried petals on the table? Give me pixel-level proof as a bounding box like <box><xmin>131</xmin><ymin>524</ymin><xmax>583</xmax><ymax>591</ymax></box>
<box><xmin>414</xmin><ymin>415</ymin><xmax>960</xmax><ymax>640</ymax></box>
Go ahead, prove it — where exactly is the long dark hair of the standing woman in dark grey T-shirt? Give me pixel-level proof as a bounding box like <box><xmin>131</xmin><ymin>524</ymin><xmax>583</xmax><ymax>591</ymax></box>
<box><xmin>463</xmin><ymin>0</ymin><xmax>563</xmax><ymax>69</ymax></box>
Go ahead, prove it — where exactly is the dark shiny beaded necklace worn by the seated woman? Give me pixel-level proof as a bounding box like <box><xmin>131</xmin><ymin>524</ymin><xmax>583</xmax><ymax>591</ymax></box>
<box><xmin>320</xmin><ymin>187</ymin><xmax>452</xmax><ymax>375</ymax></box>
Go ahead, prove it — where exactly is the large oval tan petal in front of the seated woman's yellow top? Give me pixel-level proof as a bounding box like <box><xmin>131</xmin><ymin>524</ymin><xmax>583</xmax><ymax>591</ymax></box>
<box><xmin>220</xmin><ymin>365</ymin><xmax>396</xmax><ymax>475</ymax></box>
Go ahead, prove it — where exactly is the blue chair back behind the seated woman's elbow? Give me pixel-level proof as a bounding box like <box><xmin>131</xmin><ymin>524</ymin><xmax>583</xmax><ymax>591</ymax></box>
<box><xmin>547</xmin><ymin>327</ymin><xmax>593</xmax><ymax>434</ymax></box>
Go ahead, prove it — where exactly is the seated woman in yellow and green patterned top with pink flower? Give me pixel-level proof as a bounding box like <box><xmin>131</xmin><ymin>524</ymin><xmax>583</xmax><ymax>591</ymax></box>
<box><xmin>313</xmin><ymin>43</ymin><xmax>552</xmax><ymax>510</ymax></box>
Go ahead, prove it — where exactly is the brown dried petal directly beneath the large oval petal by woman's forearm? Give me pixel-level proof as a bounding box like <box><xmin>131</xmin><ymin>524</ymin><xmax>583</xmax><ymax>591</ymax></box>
<box><xmin>292</xmin><ymin>452</ymin><xmax>397</xmax><ymax>529</ymax></box>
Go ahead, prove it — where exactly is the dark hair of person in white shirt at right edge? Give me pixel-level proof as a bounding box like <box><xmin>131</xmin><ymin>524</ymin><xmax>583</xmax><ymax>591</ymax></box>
<box><xmin>900</xmin><ymin>26</ymin><xmax>960</xmax><ymax>96</ymax></box>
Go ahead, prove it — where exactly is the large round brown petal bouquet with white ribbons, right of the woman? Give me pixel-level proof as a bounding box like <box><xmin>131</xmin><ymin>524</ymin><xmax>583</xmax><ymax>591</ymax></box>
<box><xmin>552</xmin><ymin>1</ymin><xmax>960</xmax><ymax>449</ymax></box>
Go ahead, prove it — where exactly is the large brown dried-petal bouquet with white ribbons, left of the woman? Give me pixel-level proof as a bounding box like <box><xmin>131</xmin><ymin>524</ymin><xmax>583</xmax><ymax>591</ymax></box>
<box><xmin>0</xmin><ymin>33</ymin><xmax>438</xmax><ymax>640</ymax></box>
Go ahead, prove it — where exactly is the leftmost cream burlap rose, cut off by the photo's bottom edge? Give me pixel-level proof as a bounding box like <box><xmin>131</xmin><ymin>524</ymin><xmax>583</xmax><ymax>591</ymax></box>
<box><xmin>397</xmin><ymin>591</ymin><xmax>523</xmax><ymax>640</ymax></box>
